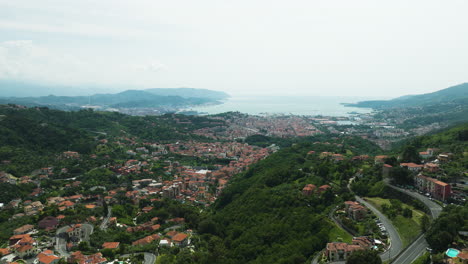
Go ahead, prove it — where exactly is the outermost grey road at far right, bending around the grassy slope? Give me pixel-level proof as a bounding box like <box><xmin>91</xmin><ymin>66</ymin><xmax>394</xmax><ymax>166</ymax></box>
<box><xmin>386</xmin><ymin>181</ymin><xmax>443</xmax><ymax>264</ymax></box>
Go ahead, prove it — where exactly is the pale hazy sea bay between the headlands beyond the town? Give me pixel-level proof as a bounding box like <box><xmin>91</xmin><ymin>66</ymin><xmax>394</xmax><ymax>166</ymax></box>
<box><xmin>186</xmin><ymin>96</ymin><xmax>375</xmax><ymax>116</ymax></box>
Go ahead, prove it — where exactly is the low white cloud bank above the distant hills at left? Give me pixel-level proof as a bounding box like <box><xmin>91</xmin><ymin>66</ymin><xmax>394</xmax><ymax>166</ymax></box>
<box><xmin>0</xmin><ymin>40</ymin><xmax>167</xmax><ymax>85</ymax></box>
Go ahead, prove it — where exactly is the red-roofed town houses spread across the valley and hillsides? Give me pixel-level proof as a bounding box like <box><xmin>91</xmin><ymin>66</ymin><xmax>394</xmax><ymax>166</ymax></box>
<box><xmin>0</xmin><ymin>105</ymin><xmax>467</xmax><ymax>263</ymax></box>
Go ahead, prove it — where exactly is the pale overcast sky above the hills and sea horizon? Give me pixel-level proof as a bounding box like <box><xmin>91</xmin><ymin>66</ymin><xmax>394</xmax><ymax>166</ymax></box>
<box><xmin>0</xmin><ymin>0</ymin><xmax>468</xmax><ymax>97</ymax></box>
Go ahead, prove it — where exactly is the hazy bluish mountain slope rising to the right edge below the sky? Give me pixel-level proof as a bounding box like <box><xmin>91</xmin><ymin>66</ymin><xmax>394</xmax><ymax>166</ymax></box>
<box><xmin>346</xmin><ymin>83</ymin><xmax>468</xmax><ymax>109</ymax></box>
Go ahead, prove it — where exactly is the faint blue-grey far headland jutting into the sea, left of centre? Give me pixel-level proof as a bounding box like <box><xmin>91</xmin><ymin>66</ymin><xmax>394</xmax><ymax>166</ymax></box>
<box><xmin>145</xmin><ymin>88</ymin><xmax>229</xmax><ymax>100</ymax></box>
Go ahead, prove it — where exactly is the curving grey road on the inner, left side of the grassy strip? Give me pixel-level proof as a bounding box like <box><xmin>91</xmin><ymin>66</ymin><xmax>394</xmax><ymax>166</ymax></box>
<box><xmin>355</xmin><ymin>195</ymin><xmax>403</xmax><ymax>261</ymax></box>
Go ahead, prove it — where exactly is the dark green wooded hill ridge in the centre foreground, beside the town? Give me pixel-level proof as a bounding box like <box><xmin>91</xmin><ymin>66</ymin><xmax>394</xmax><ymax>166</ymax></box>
<box><xmin>199</xmin><ymin>138</ymin><xmax>377</xmax><ymax>264</ymax></box>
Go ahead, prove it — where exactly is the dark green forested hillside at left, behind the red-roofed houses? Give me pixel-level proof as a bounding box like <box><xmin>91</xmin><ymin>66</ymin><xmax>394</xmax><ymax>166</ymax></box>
<box><xmin>0</xmin><ymin>105</ymin><xmax>223</xmax><ymax>175</ymax></box>
